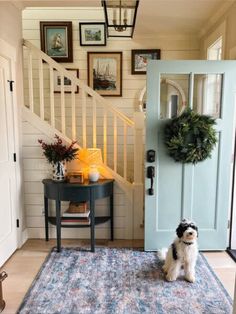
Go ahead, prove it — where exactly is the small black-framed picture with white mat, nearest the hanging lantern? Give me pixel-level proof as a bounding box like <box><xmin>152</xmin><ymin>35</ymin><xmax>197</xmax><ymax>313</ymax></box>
<box><xmin>79</xmin><ymin>23</ymin><xmax>106</xmax><ymax>46</ymax></box>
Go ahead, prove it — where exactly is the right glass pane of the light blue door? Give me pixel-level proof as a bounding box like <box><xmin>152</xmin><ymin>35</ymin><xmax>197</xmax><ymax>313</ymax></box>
<box><xmin>193</xmin><ymin>74</ymin><xmax>223</xmax><ymax>118</ymax></box>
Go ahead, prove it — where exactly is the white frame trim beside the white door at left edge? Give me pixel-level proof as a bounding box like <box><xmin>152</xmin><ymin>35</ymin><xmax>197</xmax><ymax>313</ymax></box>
<box><xmin>0</xmin><ymin>38</ymin><xmax>25</xmax><ymax>248</ymax></box>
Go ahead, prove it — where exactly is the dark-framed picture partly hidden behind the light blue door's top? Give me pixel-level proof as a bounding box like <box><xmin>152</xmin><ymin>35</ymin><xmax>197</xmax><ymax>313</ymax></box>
<box><xmin>131</xmin><ymin>49</ymin><xmax>161</xmax><ymax>74</ymax></box>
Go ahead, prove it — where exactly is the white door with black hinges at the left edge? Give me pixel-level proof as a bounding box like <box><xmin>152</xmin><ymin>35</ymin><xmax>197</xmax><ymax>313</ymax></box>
<box><xmin>0</xmin><ymin>56</ymin><xmax>17</xmax><ymax>266</ymax></box>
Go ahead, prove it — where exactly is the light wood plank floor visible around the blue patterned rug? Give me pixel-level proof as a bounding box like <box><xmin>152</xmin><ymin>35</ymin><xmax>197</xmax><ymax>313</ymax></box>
<box><xmin>0</xmin><ymin>239</ymin><xmax>236</xmax><ymax>314</ymax></box>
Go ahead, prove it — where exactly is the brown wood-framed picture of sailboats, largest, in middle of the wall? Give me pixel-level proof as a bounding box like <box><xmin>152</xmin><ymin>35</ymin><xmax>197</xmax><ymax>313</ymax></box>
<box><xmin>88</xmin><ymin>52</ymin><xmax>122</xmax><ymax>96</ymax></box>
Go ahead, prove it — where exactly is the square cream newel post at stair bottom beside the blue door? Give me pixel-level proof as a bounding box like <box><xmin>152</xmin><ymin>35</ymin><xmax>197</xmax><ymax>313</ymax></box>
<box><xmin>133</xmin><ymin>112</ymin><xmax>145</xmax><ymax>239</ymax></box>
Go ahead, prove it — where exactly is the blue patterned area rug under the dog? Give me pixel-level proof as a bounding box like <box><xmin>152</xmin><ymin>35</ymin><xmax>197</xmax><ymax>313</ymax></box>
<box><xmin>18</xmin><ymin>248</ymin><xmax>232</xmax><ymax>314</ymax></box>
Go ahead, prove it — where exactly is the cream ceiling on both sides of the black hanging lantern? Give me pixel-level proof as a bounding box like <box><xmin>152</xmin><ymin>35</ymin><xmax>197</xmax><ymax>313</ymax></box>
<box><xmin>13</xmin><ymin>0</ymin><xmax>236</xmax><ymax>37</ymax></box>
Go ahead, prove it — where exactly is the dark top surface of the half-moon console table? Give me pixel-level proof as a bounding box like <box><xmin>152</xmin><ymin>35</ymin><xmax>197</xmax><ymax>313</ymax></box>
<box><xmin>42</xmin><ymin>179</ymin><xmax>114</xmax><ymax>188</ymax></box>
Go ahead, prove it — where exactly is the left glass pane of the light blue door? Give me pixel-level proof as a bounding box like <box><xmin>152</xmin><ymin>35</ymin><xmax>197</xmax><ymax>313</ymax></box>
<box><xmin>160</xmin><ymin>74</ymin><xmax>189</xmax><ymax>119</ymax></box>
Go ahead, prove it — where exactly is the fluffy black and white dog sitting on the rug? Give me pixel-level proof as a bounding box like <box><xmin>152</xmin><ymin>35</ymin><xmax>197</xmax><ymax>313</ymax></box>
<box><xmin>162</xmin><ymin>219</ymin><xmax>198</xmax><ymax>282</ymax></box>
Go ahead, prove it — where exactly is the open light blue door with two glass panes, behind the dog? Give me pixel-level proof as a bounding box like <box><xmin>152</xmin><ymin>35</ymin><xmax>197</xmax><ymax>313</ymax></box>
<box><xmin>145</xmin><ymin>61</ymin><xmax>236</xmax><ymax>250</ymax></box>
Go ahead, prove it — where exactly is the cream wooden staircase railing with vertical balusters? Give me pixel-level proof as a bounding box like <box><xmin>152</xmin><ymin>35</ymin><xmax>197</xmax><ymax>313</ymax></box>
<box><xmin>23</xmin><ymin>40</ymin><xmax>144</xmax><ymax>183</ymax></box>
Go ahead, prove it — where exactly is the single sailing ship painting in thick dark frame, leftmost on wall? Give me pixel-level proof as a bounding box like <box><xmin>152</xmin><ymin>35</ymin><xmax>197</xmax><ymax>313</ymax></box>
<box><xmin>40</xmin><ymin>22</ymin><xmax>73</xmax><ymax>62</ymax></box>
